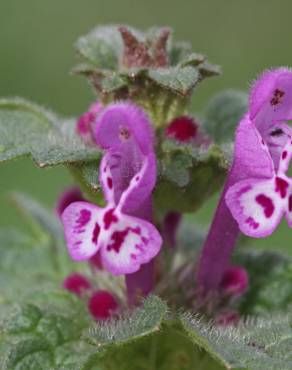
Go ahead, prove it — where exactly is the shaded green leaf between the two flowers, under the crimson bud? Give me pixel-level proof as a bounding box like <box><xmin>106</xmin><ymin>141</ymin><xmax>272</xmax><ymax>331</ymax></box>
<box><xmin>154</xmin><ymin>141</ymin><xmax>228</xmax><ymax>212</ymax></box>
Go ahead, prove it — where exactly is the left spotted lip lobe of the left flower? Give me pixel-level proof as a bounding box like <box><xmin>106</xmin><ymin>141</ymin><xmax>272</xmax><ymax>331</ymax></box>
<box><xmin>61</xmin><ymin>202</ymin><xmax>104</xmax><ymax>261</ymax></box>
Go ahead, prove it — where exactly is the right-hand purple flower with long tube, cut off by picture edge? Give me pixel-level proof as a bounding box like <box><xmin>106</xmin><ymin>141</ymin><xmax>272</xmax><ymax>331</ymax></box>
<box><xmin>197</xmin><ymin>68</ymin><xmax>292</xmax><ymax>291</ymax></box>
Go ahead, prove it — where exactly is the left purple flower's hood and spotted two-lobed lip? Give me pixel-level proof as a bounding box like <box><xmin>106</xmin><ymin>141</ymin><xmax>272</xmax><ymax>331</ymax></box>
<box><xmin>62</xmin><ymin>103</ymin><xmax>162</xmax><ymax>275</ymax></box>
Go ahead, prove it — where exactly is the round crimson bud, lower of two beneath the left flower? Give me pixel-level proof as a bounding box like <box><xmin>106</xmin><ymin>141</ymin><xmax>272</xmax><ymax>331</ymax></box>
<box><xmin>88</xmin><ymin>290</ymin><xmax>118</xmax><ymax>321</ymax></box>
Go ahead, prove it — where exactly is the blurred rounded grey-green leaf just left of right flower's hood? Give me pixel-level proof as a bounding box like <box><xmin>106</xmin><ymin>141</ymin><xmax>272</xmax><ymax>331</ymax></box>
<box><xmin>204</xmin><ymin>90</ymin><xmax>247</xmax><ymax>143</ymax></box>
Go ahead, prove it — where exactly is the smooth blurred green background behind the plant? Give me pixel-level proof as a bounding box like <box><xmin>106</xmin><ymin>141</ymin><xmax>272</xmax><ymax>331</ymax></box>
<box><xmin>0</xmin><ymin>0</ymin><xmax>292</xmax><ymax>254</ymax></box>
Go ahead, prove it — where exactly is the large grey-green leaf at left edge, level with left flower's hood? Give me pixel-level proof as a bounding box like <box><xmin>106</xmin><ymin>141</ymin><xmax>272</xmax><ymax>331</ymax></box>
<box><xmin>0</xmin><ymin>98</ymin><xmax>99</xmax><ymax>167</ymax></box>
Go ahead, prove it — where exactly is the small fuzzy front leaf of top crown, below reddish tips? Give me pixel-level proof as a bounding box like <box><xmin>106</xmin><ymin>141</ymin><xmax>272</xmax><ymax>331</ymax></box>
<box><xmin>148</xmin><ymin>66</ymin><xmax>200</xmax><ymax>96</ymax></box>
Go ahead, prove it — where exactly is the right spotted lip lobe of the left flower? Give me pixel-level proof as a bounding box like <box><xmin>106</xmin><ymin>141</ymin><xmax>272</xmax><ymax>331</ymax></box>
<box><xmin>101</xmin><ymin>214</ymin><xmax>162</xmax><ymax>275</ymax></box>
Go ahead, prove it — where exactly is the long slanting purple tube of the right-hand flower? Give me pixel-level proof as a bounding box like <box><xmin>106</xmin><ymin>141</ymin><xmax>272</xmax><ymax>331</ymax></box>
<box><xmin>196</xmin><ymin>167</ymin><xmax>239</xmax><ymax>295</ymax></box>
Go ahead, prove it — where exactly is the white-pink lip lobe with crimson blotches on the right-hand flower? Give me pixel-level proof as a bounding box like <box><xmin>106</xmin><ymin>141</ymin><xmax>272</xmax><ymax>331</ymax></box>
<box><xmin>225</xmin><ymin>178</ymin><xmax>288</xmax><ymax>238</ymax></box>
